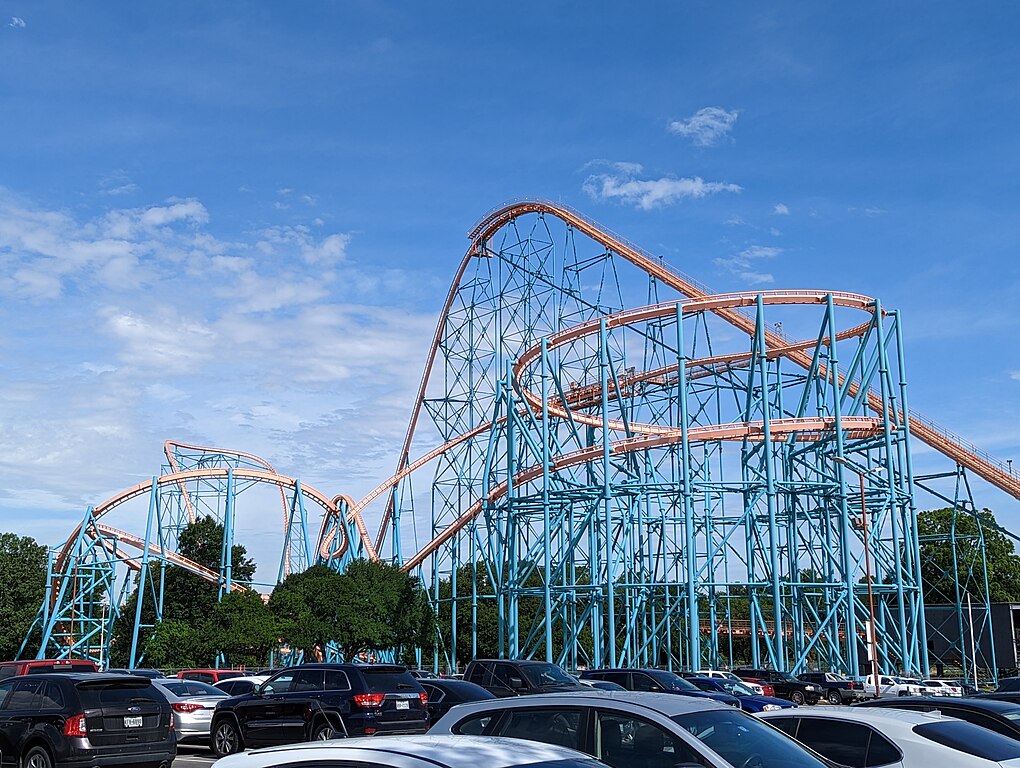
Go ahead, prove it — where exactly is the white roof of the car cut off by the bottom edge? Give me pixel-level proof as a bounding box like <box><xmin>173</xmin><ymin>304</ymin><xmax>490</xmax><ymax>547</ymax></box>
<box><xmin>215</xmin><ymin>734</ymin><xmax>601</xmax><ymax>768</ymax></box>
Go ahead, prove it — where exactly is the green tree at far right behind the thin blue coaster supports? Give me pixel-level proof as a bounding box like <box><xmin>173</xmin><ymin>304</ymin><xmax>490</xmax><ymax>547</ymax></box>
<box><xmin>917</xmin><ymin>508</ymin><xmax>1020</xmax><ymax>605</ymax></box>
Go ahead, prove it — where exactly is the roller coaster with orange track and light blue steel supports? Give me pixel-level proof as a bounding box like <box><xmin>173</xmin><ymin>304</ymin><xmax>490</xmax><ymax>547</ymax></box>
<box><xmin>25</xmin><ymin>200</ymin><xmax>1020</xmax><ymax>674</ymax></box>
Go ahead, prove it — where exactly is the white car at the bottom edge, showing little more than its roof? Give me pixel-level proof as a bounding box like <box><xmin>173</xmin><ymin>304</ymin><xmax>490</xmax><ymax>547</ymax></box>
<box><xmin>207</xmin><ymin>735</ymin><xmax>608</xmax><ymax>768</ymax></box>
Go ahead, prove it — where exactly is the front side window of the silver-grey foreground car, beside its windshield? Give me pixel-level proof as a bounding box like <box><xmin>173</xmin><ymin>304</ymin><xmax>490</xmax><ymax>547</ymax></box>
<box><xmin>595</xmin><ymin>711</ymin><xmax>710</xmax><ymax>768</ymax></box>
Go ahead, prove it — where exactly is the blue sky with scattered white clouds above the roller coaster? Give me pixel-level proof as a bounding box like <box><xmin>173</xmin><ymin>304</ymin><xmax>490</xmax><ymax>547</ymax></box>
<box><xmin>0</xmin><ymin>0</ymin><xmax>1020</xmax><ymax>571</ymax></box>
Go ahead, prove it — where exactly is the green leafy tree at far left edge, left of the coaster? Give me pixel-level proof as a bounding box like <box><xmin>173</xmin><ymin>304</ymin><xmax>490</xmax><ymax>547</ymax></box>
<box><xmin>0</xmin><ymin>533</ymin><xmax>46</xmax><ymax>659</ymax></box>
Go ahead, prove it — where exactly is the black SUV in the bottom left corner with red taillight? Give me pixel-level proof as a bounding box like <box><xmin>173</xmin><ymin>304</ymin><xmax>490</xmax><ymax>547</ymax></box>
<box><xmin>0</xmin><ymin>672</ymin><xmax>177</xmax><ymax>768</ymax></box>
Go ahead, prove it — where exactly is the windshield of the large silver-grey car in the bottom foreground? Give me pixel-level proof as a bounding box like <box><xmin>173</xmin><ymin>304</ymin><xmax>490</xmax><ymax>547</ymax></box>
<box><xmin>672</xmin><ymin>709</ymin><xmax>827</xmax><ymax>768</ymax></box>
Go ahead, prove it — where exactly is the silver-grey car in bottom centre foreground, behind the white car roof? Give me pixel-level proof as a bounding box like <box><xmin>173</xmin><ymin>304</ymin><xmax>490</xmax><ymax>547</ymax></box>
<box><xmin>431</xmin><ymin>690</ymin><xmax>832</xmax><ymax>768</ymax></box>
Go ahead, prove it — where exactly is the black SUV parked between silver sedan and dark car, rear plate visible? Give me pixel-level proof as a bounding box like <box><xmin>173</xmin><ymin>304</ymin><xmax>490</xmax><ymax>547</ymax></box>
<box><xmin>211</xmin><ymin>664</ymin><xmax>428</xmax><ymax>757</ymax></box>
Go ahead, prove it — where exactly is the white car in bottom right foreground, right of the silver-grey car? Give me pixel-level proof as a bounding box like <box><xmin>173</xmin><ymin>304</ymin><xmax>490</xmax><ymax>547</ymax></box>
<box><xmin>759</xmin><ymin>707</ymin><xmax>1020</xmax><ymax>768</ymax></box>
